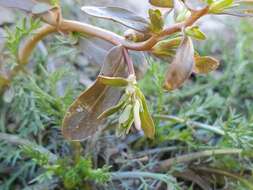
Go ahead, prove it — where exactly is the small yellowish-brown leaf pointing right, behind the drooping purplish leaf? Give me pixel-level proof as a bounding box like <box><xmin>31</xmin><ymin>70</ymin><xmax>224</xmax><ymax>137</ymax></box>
<box><xmin>193</xmin><ymin>56</ymin><xmax>219</xmax><ymax>74</ymax></box>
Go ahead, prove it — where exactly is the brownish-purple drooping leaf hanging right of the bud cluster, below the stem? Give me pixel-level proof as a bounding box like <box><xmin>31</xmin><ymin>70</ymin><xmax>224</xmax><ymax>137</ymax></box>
<box><xmin>164</xmin><ymin>36</ymin><xmax>194</xmax><ymax>90</ymax></box>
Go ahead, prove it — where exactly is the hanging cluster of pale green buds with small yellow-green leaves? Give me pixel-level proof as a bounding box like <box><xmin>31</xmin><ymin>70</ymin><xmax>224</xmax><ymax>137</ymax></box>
<box><xmin>98</xmin><ymin>75</ymin><xmax>155</xmax><ymax>138</ymax></box>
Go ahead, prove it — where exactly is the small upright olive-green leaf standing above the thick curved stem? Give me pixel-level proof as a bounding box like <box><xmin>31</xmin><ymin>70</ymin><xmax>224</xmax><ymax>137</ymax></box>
<box><xmin>148</xmin><ymin>9</ymin><xmax>164</xmax><ymax>33</ymax></box>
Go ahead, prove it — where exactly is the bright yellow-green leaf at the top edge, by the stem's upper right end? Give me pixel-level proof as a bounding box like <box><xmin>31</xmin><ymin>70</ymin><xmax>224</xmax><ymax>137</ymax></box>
<box><xmin>209</xmin><ymin>0</ymin><xmax>234</xmax><ymax>14</ymax></box>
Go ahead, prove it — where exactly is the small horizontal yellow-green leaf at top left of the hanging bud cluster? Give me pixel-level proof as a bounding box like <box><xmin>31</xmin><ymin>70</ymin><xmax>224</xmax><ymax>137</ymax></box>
<box><xmin>97</xmin><ymin>75</ymin><xmax>128</xmax><ymax>87</ymax></box>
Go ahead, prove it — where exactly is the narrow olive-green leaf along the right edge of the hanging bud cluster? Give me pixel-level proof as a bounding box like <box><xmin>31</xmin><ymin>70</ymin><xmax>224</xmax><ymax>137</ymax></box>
<box><xmin>136</xmin><ymin>88</ymin><xmax>155</xmax><ymax>139</ymax></box>
